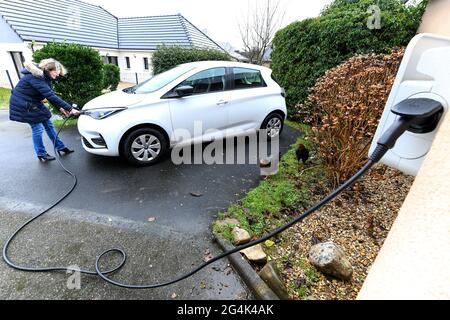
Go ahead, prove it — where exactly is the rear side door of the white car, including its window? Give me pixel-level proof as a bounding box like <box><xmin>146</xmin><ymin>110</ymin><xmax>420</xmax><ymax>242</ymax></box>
<box><xmin>227</xmin><ymin>68</ymin><xmax>270</xmax><ymax>133</ymax></box>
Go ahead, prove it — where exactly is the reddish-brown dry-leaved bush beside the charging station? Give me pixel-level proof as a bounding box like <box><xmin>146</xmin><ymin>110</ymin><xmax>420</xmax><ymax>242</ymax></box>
<box><xmin>308</xmin><ymin>49</ymin><xmax>404</xmax><ymax>186</ymax></box>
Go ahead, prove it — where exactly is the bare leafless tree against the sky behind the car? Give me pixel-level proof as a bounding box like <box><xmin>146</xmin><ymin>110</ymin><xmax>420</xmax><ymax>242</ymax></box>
<box><xmin>239</xmin><ymin>0</ymin><xmax>284</xmax><ymax>65</ymax></box>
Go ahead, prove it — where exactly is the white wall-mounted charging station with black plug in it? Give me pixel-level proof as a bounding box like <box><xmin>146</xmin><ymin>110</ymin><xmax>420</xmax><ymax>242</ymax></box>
<box><xmin>369</xmin><ymin>34</ymin><xmax>450</xmax><ymax>175</ymax></box>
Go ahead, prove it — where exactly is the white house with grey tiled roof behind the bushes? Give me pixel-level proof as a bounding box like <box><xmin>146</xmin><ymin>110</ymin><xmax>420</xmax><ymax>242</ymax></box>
<box><xmin>0</xmin><ymin>0</ymin><xmax>223</xmax><ymax>86</ymax></box>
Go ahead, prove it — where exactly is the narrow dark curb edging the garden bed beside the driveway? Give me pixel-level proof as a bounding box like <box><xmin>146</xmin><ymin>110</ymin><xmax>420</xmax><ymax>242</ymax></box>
<box><xmin>214</xmin><ymin>232</ymin><xmax>281</xmax><ymax>301</ymax></box>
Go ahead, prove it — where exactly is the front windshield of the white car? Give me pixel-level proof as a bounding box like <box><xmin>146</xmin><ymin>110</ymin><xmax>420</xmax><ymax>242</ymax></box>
<box><xmin>125</xmin><ymin>65</ymin><xmax>194</xmax><ymax>94</ymax></box>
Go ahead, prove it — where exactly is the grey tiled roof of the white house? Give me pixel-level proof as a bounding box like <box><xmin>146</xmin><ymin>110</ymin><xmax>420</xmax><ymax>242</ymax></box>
<box><xmin>0</xmin><ymin>0</ymin><xmax>222</xmax><ymax>50</ymax></box>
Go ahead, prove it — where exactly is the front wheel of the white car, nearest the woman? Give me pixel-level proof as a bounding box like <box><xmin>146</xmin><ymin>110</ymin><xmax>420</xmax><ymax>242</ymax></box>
<box><xmin>122</xmin><ymin>128</ymin><xmax>169</xmax><ymax>167</ymax></box>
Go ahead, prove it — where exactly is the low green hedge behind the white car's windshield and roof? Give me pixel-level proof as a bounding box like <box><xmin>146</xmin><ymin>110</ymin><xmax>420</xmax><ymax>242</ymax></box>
<box><xmin>152</xmin><ymin>46</ymin><xmax>231</xmax><ymax>74</ymax></box>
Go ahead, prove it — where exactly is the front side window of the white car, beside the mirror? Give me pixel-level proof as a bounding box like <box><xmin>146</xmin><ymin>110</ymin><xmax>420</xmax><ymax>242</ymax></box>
<box><xmin>177</xmin><ymin>68</ymin><xmax>226</xmax><ymax>94</ymax></box>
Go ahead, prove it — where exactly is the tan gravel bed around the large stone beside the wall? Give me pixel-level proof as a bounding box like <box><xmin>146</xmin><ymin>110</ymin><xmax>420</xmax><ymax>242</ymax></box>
<box><xmin>267</xmin><ymin>165</ymin><xmax>414</xmax><ymax>300</ymax></box>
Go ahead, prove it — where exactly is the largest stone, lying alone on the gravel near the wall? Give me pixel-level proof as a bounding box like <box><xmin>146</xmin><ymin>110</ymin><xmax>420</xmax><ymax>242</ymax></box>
<box><xmin>308</xmin><ymin>242</ymin><xmax>353</xmax><ymax>281</ymax></box>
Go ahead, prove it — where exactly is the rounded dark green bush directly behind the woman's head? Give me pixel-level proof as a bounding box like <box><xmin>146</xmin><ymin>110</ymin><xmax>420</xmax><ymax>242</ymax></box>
<box><xmin>33</xmin><ymin>43</ymin><xmax>103</xmax><ymax>113</ymax></box>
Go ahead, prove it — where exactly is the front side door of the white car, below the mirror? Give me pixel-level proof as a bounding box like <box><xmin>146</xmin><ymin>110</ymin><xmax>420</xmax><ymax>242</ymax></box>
<box><xmin>169</xmin><ymin>68</ymin><xmax>229</xmax><ymax>142</ymax></box>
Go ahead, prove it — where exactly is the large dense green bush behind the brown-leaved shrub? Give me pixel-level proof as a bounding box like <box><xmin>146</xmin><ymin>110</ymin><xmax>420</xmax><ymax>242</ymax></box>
<box><xmin>271</xmin><ymin>0</ymin><xmax>427</xmax><ymax>116</ymax></box>
